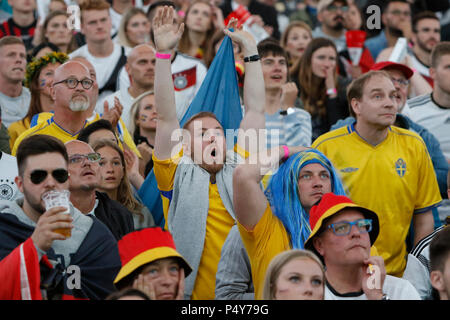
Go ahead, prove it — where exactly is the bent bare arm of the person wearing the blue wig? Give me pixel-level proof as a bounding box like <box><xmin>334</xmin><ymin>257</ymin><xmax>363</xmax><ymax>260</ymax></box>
<box><xmin>233</xmin><ymin>146</ymin><xmax>307</xmax><ymax>230</ymax></box>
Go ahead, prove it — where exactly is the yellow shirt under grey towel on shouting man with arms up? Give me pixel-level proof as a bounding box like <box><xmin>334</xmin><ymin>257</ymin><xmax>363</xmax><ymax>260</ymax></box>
<box><xmin>153</xmin><ymin>151</ymin><xmax>235</xmax><ymax>300</ymax></box>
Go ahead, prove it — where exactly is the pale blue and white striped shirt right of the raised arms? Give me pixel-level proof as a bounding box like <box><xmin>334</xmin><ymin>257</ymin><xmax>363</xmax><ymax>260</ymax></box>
<box><xmin>265</xmin><ymin>108</ymin><xmax>311</xmax><ymax>149</ymax></box>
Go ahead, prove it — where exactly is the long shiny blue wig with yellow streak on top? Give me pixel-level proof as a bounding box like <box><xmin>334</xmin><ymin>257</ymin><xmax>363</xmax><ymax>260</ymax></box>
<box><xmin>265</xmin><ymin>149</ymin><xmax>346</xmax><ymax>249</ymax></box>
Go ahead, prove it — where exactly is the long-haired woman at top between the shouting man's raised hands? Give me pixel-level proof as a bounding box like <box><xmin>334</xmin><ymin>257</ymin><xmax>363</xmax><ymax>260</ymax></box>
<box><xmin>178</xmin><ymin>0</ymin><xmax>224</xmax><ymax>59</ymax></box>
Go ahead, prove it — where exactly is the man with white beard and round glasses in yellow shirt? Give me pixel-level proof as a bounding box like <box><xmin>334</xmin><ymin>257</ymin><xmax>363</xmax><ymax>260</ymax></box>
<box><xmin>12</xmin><ymin>61</ymin><xmax>96</xmax><ymax>154</ymax></box>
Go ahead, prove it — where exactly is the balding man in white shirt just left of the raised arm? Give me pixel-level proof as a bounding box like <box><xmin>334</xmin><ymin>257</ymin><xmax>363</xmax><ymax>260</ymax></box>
<box><xmin>96</xmin><ymin>44</ymin><xmax>155</xmax><ymax>128</ymax></box>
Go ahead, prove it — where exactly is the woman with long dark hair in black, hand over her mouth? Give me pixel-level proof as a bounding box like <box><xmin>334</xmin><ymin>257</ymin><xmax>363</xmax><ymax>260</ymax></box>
<box><xmin>293</xmin><ymin>38</ymin><xmax>349</xmax><ymax>141</ymax></box>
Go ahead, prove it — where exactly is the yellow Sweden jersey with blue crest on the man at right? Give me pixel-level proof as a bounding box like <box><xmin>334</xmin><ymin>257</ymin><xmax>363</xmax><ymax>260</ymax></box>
<box><xmin>312</xmin><ymin>125</ymin><xmax>442</xmax><ymax>277</ymax></box>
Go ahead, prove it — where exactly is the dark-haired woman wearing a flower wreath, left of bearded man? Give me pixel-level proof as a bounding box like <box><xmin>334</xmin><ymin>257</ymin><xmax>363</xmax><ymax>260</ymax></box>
<box><xmin>8</xmin><ymin>52</ymin><xmax>69</xmax><ymax>149</ymax></box>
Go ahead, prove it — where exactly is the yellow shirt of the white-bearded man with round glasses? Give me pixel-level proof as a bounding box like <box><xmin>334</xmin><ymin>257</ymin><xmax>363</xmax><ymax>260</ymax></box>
<box><xmin>11</xmin><ymin>112</ymin><xmax>141</xmax><ymax>157</ymax></box>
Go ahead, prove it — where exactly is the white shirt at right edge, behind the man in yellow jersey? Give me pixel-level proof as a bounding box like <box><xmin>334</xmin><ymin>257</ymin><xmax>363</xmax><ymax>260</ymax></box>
<box><xmin>404</xmin><ymin>94</ymin><xmax>450</xmax><ymax>159</ymax></box>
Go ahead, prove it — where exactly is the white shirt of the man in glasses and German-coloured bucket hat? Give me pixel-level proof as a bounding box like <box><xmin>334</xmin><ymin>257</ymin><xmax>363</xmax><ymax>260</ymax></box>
<box><xmin>324</xmin><ymin>275</ymin><xmax>421</xmax><ymax>300</ymax></box>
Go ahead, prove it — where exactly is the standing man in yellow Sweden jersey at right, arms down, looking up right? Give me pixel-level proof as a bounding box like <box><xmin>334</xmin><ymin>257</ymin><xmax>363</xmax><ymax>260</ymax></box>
<box><xmin>312</xmin><ymin>71</ymin><xmax>442</xmax><ymax>277</ymax></box>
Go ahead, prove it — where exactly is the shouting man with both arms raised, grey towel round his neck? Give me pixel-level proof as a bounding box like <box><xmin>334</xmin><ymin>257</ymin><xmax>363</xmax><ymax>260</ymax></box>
<box><xmin>153</xmin><ymin>7</ymin><xmax>265</xmax><ymax>299</ymax></box>
